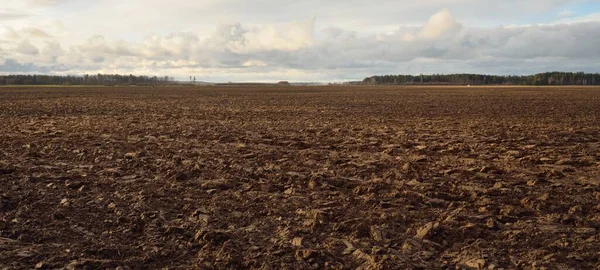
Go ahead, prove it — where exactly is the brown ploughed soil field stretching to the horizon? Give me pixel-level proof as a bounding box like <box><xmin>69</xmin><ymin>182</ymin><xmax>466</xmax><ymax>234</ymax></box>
<box><xmin>0</xmin><ymin>86</ymin><xmax>600</xmax><ymax>269</ymax></box>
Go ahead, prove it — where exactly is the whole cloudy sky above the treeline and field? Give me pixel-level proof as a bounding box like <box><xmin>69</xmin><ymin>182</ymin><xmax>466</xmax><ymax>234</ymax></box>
<box><xmin>0</xmin><ymin>0</ymin><xmax>600</xmax><ymax>82</ymax></box>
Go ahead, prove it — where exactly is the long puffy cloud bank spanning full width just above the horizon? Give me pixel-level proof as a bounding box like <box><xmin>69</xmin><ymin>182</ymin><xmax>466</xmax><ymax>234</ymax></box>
<box><xmin>0</xmin><ymin>5</ymin><xmax>600</xmax><ymax>81</ymax></box>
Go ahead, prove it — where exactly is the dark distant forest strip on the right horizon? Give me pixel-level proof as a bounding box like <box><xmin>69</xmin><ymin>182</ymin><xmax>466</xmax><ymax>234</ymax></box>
<box><xmin>362</xmin><ymin>72</ymin><xmax>600</xmax><ymax>85</ymax></box>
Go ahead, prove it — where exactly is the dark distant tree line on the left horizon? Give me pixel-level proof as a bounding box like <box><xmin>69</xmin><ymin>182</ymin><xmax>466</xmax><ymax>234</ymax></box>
<box><xmin>0</xmin><ymin>74</ymin><xmax>175</xmax><ymax>85</ymax></box>
